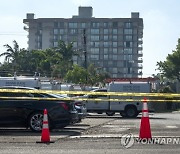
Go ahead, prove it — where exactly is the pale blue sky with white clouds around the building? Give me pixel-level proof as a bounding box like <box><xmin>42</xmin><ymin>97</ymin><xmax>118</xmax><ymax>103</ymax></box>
<box><xmin>0</xmin><ymin>0</ymin><xmax>180</xmax><ymax>77</ymax></box>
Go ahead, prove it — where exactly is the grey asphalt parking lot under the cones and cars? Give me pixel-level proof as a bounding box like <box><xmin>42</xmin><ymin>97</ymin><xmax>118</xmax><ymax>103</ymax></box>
<box><xmin>0</xmin><ymin>112</ymin><xmax>180</xmax><ymax>154</ymax></box>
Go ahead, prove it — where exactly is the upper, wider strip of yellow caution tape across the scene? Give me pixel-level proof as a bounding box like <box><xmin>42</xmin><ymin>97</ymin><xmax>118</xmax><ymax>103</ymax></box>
<box><xmin>0</xmin><ymin>89</ymin><xmax>180</xmax><ymax>98</ymax></box>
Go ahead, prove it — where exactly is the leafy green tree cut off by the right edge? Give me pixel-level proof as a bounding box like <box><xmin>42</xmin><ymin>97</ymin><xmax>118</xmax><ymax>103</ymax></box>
<box><xmin>157</xmin><ymin>39</ymin><xmax>180</xmax><ymax>82</ymax></box>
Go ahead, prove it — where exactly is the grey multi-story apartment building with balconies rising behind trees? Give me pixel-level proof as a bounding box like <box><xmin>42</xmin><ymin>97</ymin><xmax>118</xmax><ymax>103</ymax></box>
<box><xmin>23</xmin><ymin>7</ymin><xmax>143</xmax><ymax>78</ymax></box>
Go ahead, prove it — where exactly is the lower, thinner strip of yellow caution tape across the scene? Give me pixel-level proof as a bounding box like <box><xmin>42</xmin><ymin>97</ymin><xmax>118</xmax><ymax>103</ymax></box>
<box><xmin>0</xmin><ymin>97</ymin><xmax>180</xmax><ymax>103</ymax></box>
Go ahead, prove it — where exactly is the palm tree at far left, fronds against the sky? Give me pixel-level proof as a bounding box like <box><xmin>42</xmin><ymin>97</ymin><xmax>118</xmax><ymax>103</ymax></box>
<box><xmin>0</xmin><ymin>40</ymin><xmax>20</xmax><ymax>71</ymax></box>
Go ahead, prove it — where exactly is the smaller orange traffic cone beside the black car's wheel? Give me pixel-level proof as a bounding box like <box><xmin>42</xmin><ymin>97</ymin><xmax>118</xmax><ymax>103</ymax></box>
<box><xmin>37</xmin><ymin>109</ymin><xmax>53</xmax><ymax>143</ymax></box>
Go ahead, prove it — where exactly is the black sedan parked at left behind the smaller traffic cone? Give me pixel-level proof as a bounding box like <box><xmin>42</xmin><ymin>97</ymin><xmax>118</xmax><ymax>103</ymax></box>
<box><xmin>0</xmin><ymin>87</ymin><xmax>78</xmax><ymax>131</ymax></box>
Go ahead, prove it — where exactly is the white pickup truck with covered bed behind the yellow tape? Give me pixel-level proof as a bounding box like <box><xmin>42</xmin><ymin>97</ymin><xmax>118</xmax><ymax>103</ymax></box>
<box><xmin>87</xmin><ymin>82</ymin><xmax>153</xmax><ymax>118</ymax></box>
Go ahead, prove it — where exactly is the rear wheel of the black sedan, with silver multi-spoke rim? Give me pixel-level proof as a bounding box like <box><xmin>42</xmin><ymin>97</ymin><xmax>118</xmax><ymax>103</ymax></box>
<box><xmin>29</xmin><ymin>112</ymin><xmax>43</xmax><ymax>132</ymax></box>
